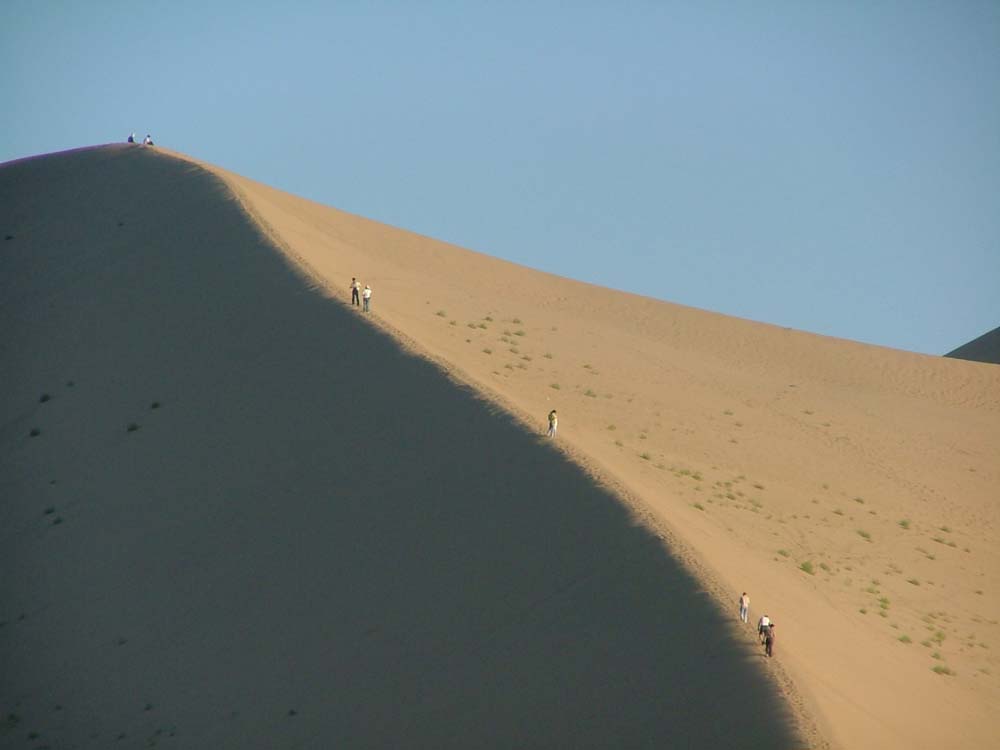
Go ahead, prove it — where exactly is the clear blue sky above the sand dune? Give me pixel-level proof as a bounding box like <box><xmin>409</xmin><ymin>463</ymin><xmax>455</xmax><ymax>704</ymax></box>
<box><xmin>0</xmin><ymin>0</ymin><xmax>1000</xmax><ymax>354</ymax></box>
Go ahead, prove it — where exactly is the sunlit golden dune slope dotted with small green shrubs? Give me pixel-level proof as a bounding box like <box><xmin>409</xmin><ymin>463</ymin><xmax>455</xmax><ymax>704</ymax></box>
<box><xmin>174</xmin><ymin>144</ymin><xmax>1000</xmax><ymax>748</ymax></box>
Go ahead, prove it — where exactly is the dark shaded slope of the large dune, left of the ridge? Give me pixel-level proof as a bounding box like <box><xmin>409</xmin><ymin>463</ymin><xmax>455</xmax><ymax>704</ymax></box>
<box><xmin>0</xmin><ymin>147</ymin><xmax>797</xmax><ymax>748</ymax></box>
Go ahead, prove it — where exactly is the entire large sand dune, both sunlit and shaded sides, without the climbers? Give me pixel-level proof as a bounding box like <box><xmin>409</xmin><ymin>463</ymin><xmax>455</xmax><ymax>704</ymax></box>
<box><xmin>0</xmin><ymin>146</ymin><xmax>1000</xmax><ymax>748</ymax></box>
